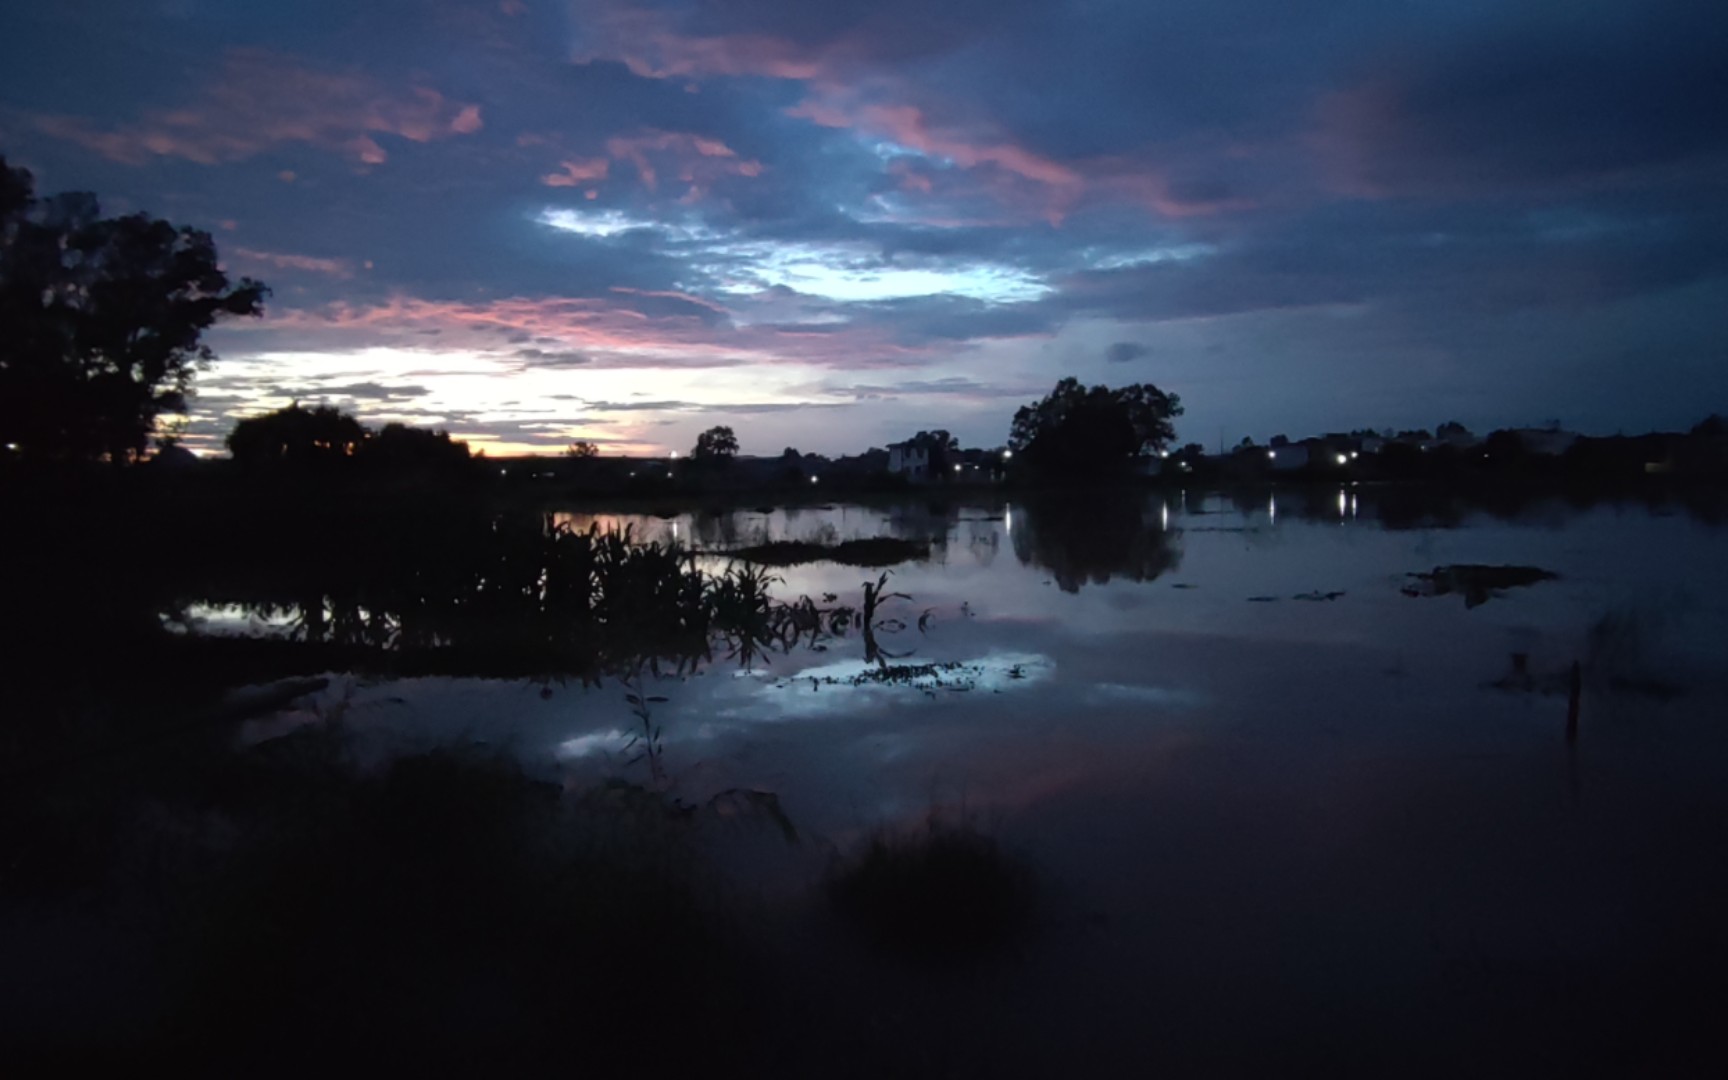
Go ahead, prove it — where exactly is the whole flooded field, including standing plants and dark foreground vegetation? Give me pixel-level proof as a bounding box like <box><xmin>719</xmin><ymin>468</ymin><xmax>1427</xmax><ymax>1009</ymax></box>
<box><xmin>16</xmin><ymin>486</ymin><xmax>1728</xmax><ymax>1077</ymax></box>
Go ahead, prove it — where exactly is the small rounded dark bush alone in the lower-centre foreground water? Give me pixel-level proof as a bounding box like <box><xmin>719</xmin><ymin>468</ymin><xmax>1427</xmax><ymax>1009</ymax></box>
<box><xmin>828</xmin><ymin>819</ymin><xmax>1033</xmax><ymax>961</ymax></box>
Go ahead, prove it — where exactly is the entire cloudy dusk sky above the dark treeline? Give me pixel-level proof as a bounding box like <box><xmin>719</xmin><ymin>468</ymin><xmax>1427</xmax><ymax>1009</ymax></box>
<box><xmin>0</xmin><ymin>0</ymin><xmax>1728</xmax><ymax>454</ymax></box>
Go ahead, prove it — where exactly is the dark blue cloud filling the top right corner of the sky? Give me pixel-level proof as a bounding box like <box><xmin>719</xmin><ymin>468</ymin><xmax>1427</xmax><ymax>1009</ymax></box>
<box><xmin>1312</xmin><ymin>2</ymin><xmax>1728</xmax><ymax>197</ymax></box>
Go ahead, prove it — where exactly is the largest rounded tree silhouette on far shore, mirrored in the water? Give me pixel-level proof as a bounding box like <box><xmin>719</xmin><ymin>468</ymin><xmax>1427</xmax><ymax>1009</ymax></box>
<box><xmin>1007</xmin><ymin>377</ymin><xmax>1182</xmax><ymax>472</ymax></box>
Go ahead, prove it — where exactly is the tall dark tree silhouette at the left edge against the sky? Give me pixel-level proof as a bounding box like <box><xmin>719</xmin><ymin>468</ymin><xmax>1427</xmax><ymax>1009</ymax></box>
<box><xmin>0</xmin><ymin>159</ymin><xmax>268</xmax><ymax>463</ymax></box>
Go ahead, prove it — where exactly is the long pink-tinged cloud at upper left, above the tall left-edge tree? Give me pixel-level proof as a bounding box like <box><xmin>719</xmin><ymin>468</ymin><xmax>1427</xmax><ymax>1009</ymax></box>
<box><xmin>33</xmin><ymin>48</ymin><xmax>482</xmax><ymax>166</ymax></box>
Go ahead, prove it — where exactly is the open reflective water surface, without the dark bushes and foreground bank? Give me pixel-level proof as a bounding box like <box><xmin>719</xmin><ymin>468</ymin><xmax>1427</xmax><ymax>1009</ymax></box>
<box><xmin>226</xmin><ymin>487</ymin><xmax>1728</xmax><ymax>1075</ymax></box>
